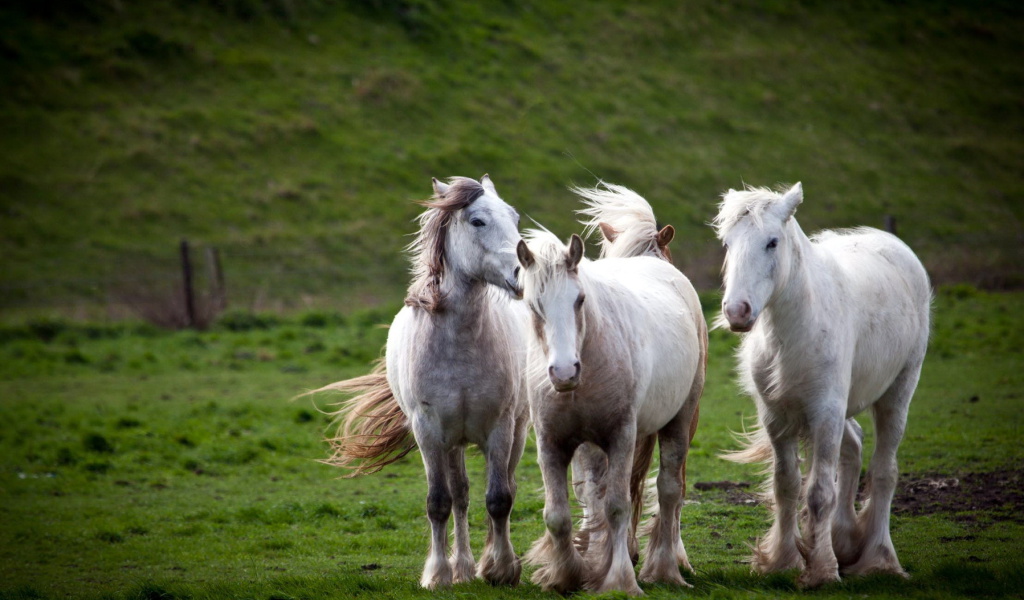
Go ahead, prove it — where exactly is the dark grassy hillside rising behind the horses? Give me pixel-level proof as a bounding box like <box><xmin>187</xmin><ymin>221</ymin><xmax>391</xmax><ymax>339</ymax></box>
<box><xmin>0</xmin><ymin>0</ymin><xmax>1024</xmax><ymax>317</ymax></box>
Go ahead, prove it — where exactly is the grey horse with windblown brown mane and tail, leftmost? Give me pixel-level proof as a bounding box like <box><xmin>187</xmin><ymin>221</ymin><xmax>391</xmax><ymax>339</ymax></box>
<box><xmin>310</xmin><ymin>175</ymin><xmax>529</xmax><ymax>589</ymax></box>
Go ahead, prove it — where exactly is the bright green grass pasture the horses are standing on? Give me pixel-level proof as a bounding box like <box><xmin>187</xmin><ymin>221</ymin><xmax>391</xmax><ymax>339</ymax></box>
<box><xmin>0</xmin><ymin>286</ymin><xmax>1024</xmax><ymax>600</ymax></box>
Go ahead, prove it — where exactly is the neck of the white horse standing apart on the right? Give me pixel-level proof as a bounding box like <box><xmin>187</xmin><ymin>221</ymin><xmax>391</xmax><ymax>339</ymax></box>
<box><xmin>763</xmin><ymin>218</ymin><xmax>821</xmax><ymax>337</ymax></box>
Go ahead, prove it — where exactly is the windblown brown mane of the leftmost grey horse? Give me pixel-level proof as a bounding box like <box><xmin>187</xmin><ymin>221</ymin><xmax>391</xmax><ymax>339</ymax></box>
<box><xmin>406</xmin><ymin>177</ymin><xmax>484</xmax><ymax>312</ymax></box>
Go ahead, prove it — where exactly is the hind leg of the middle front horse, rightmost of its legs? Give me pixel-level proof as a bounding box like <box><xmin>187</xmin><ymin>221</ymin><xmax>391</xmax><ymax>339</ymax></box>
<box><xmin>640</xmin><ymin>401</ymin><xmax>696</xmax><ymax>587</ymax></box>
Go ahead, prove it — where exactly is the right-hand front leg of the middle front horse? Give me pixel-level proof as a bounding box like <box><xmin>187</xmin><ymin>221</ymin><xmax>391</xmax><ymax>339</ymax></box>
<box><xmin>585</xmin><ymin>425</ymin><xmax>643</xmax><ymax>596</ymax></box>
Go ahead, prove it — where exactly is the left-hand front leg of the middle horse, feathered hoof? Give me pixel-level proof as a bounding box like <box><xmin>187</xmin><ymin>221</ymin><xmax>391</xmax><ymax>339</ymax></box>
<box><xmin>523</xmin><ymin>429</ymin><xmax>586</xmax><ymax>594</ymax></box>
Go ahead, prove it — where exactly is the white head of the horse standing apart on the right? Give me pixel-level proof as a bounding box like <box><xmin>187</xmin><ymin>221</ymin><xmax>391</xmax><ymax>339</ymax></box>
<box><xmin>714</xmin><ymin>183</ymin><xmax>804</xmax><ymax>332</ymax></box>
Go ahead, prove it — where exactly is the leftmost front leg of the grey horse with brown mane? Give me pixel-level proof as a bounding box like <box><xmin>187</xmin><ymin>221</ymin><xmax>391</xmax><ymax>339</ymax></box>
<box><xmin>416</xmin><ymin>442</ymin><xmax>452</xmax><ymax>590</ymax></box>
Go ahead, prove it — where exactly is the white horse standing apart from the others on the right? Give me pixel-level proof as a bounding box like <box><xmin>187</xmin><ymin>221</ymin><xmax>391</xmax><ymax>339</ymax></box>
<box><xmin>713</xmin><ymin>183</ymin><xmax>932</xmax><ymax>588</ymax></box>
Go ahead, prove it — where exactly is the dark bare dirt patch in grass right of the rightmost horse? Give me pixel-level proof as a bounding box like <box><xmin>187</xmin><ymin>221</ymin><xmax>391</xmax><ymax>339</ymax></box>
<box><xmin>893</xmin><ymin>469</ymin><xmax>1024</xmax><ymax>522</ymax></box>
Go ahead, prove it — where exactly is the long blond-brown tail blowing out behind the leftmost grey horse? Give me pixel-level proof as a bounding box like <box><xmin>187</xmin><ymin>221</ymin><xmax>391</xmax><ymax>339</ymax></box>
<box><xmin>309</xmin><ymin>359</ymin><xmax>416</xmax><ymax>477</ymax></box>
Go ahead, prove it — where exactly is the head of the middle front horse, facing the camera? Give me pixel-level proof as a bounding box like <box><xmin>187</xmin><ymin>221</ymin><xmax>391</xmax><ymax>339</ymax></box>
<box><xmin>516</xmin><ymin>230</ymin><xmax>586</xmax><ymax>392</ymax></box>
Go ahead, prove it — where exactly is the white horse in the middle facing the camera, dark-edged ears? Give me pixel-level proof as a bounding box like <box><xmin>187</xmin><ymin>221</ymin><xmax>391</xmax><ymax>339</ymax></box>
<box><xmin>517</xmin><ymin>225</ymin><xmax>708</xmax><ymax>595</ymax></box>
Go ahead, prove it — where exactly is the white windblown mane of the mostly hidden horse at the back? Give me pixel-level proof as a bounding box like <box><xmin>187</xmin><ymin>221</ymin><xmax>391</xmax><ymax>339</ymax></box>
<box><xmin>569</xmin><ymin>181</ymin><xmax>660</xmax><ymax>258</ymax></box>
